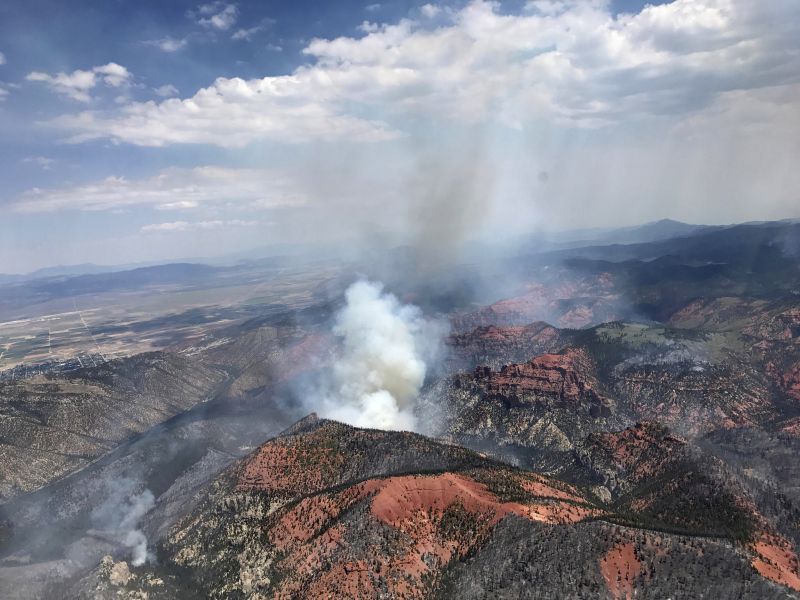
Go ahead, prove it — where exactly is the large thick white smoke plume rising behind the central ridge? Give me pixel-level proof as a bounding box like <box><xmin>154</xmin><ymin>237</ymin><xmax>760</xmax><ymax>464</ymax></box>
<box><xmin>318</xmin><ymin>281</ymin><xmax>442</xmax><ymax>430</ymax></box>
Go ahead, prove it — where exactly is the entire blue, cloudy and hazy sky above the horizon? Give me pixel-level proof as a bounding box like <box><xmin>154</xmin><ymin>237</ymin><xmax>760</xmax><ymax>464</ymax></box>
<box><xmin>0</xmin><ymin>0</ymin><xmax>800</xmax><ymax>273</ymax></box>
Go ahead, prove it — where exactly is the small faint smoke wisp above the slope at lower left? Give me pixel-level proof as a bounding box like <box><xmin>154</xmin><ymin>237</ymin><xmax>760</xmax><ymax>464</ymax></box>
<box><xmin>92</xmin><ymin>478</ymin><xmax>155</xmax><ymax>567</ymax></box>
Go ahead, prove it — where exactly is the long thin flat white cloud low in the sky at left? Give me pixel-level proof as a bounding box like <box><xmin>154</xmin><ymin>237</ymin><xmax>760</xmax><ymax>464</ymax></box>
<box><xmin>12</xmin><ymin>166</ymin><xmax>305</xmax><ymax>213</ymax></box>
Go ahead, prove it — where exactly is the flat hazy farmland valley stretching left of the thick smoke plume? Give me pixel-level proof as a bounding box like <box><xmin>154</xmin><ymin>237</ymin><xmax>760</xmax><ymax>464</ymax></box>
<box><xmin>0</xmin><ymin>263</ymin><xmax>339</xmax><ymax>378</ymax></box>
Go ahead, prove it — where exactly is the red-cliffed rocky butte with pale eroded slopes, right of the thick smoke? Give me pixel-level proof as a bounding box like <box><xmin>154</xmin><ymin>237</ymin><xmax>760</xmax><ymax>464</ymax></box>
<box><xmin>422</xmin><ymin>348</ymin><xmax>629</xmax><ymax>471</ymax></box>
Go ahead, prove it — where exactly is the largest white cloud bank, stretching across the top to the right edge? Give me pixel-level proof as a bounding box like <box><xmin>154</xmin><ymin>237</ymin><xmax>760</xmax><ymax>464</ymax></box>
<box><xmin>34</xmin><ymin>0</ymin><xmax>800</xmax><ymax>146</ymax></box>
